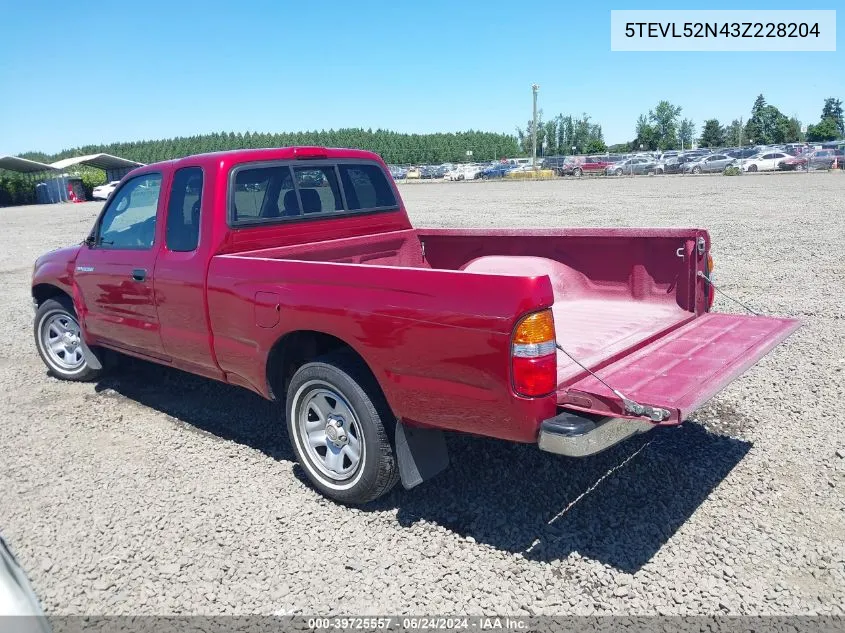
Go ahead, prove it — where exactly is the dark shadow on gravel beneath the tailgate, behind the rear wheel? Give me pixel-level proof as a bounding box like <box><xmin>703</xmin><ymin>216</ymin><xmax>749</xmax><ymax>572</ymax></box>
<box><xmin>376</xmin><ymin>422</ymin><xmax>751</xmax><ymax>573</ymax></box>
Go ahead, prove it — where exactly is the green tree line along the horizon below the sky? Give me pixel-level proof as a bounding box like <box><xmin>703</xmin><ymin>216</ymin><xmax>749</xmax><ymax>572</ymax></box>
<box><xmin>0</xmin><ymin>95</ymin><xmax>845</xmax><ymax>206</ymax></box>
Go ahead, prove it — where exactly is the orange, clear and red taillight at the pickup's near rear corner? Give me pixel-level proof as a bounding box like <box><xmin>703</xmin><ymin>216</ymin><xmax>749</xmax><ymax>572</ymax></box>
<box><xmin>511</xmin><ymin>310</ymin><xmax>557</xmax><ymax>397</ymax></box>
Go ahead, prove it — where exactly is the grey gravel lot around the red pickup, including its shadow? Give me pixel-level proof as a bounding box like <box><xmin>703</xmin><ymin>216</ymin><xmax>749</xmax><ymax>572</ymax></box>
<box><xmin>0</xmin><ymin>174</ymin><xmax>845</xmax><ymax>614</ymax></box>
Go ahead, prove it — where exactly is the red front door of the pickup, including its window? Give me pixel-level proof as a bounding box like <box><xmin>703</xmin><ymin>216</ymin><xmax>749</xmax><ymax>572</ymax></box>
<box><xmin>74</xmin><ymin>172</ymin><xmax>166</xmax><ymax>358</ymax></box>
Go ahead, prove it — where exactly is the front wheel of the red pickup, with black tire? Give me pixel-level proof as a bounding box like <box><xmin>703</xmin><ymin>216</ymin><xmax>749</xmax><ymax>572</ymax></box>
<box><xmin>33</xmin><ymin>295</ymin><xmax>102</xmax><ymax>382</ymax></box>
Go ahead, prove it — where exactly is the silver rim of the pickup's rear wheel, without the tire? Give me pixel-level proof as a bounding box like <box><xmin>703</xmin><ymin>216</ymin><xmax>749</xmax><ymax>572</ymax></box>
<box><xmin>296</xmin><ymin>382</ymin><xmax>364</xmax><ymax>482</ymax></box>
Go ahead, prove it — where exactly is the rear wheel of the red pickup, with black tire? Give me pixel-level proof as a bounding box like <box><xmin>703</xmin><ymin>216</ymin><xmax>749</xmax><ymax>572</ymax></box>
<box><xmin>285</xmin><ymin>353</ymin><xmax>399</xmax><ymax>505</ymax></box>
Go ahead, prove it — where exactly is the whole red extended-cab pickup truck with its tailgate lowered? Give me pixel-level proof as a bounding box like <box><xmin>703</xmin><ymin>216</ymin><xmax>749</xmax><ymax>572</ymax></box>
<box><xmin>32</xmin><ymin>147</ymin><xmax>798</xmax><ymax>503</ymax></box>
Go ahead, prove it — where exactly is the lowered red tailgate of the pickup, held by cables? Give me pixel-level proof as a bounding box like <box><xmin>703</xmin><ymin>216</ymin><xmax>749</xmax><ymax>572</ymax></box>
<box><xmin>558</xmin><ymin>314</ymin><xmax>801</xmax><ymax>424</ymax></box>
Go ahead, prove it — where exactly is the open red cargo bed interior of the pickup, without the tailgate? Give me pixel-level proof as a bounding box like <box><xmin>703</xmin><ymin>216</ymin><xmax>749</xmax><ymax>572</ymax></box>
<box><xmin>232</xmin><ymin>229</ymin><xmax>695</xmax><ymax>388</ymax></box>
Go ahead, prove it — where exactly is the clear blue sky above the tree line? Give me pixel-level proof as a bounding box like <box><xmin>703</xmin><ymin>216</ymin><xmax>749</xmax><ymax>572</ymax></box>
<box><xmin>0</xmin><ymin>0</ymin><xmax>845</xmax><ymax>154</ymax></box>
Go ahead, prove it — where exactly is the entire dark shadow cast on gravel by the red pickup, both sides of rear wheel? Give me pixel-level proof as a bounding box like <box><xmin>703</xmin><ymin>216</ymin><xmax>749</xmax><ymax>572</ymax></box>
<box><xmin>96</xmin><ymin>360</ymin><xmax>751</xmax><ymax>573</ymax></box>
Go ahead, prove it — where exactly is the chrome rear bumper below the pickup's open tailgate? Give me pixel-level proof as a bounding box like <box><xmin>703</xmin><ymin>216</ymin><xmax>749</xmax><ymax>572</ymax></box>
<box><xmin>537</xmin><ymin>411</ymin><xmax>654</xmax><ymax>457</ymax></box>
